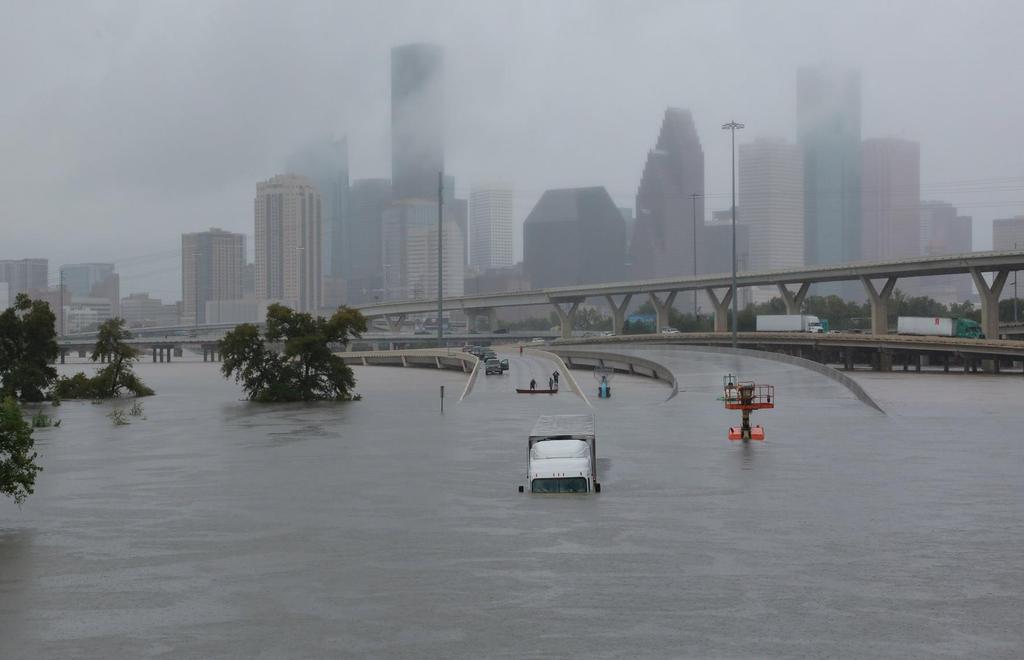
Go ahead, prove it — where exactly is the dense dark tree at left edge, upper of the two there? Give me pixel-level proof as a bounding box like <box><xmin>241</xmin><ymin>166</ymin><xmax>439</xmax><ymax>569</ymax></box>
<box><xmin>0</xmin><ymin>294</ymin><xmax>59</xmax><ymax>401</ymax></box>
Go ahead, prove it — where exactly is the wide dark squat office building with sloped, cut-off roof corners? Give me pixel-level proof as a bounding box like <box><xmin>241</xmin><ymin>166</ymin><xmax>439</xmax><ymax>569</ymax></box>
<box><xmin>522</xmin><ymin>187</ymin><xmax>626</xmax><ymax>289</ymax></box>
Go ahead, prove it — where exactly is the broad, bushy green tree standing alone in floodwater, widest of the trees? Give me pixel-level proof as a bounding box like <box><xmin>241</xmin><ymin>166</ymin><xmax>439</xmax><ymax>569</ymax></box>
<box><xmin>220</xmin><ymin>305</ymin><xmax>367</xmax><ymax>401</ymax></box>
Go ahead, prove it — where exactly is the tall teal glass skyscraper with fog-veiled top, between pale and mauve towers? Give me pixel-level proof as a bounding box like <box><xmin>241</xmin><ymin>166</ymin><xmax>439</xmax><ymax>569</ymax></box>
<box><xmin>797</xmin><ymin>68</ymin><xmax>861</xmax><ymax>268</ymax></box>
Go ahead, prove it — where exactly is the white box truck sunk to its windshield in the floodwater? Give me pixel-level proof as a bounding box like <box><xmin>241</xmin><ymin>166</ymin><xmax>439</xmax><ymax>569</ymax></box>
<box><xmin>519</xmin><ymin>414</ymin><xmax>601</xmax><ymax>493</ymax></box>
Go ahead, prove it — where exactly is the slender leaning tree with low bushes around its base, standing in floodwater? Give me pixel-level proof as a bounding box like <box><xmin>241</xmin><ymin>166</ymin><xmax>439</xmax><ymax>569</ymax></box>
<box><xmin>53</xmin><ymin>318</ymin><xmax>154</xmax><ymax>399</ymax></box>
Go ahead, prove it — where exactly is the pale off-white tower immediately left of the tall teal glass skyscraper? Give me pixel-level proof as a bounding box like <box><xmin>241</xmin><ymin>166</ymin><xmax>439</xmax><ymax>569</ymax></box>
<box><xmin>730</xmin><ymin>139</ymin><xmax>804</xmax><ymax>272</ymax></box>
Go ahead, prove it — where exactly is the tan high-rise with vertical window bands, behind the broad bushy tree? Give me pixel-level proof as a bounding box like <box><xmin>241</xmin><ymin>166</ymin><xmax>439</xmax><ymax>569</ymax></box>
<box><xmin>255</xmin><ymin>174</ymin><xmax>323</xmax><ymax>312</ymax></box>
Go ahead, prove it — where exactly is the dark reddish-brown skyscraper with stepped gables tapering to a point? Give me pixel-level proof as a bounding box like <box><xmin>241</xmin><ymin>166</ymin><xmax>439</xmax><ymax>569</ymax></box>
<box><xmin>630</xmin><ymin>107</ymin><xmax>705</xmax><ymax>278</ymax></box>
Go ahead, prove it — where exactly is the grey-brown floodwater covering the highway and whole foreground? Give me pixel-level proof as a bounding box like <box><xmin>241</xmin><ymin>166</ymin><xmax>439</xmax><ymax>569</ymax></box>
<box><xmin>0</xmin><ymin>349</ymin><xmax>1024</xmax><ymax>659</ymax></box>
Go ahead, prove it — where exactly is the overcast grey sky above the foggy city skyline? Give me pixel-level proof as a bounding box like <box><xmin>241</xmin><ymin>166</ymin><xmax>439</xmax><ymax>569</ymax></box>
<box><xmin>0</xmin><ymin>0</ymin><xmax>1024</xmax><ymax>300</ymax></box>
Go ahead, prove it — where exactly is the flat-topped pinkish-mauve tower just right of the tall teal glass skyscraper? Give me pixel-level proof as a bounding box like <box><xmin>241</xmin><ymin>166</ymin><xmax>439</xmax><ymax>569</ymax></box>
<box><xmin>860</xmin><ymin>138</ymin><xmax>921</xmax><ymax>261</ymax></box>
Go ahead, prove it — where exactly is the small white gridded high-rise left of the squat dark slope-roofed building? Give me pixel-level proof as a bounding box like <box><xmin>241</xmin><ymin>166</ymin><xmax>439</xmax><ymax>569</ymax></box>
<box><xmin>469</xmin><ymin>184</ymin><xmax>515</xmax><ymax>270</ymax></box>
